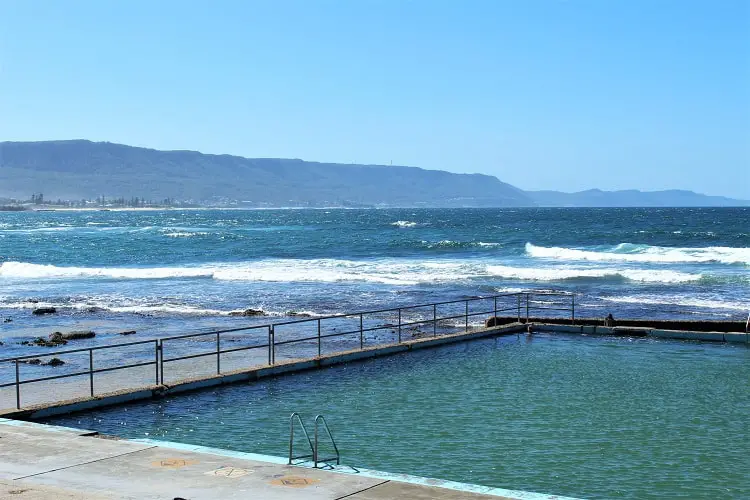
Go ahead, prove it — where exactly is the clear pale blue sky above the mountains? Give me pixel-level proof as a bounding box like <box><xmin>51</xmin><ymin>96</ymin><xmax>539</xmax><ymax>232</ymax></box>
<box><xmin>0</xmin><ymin>0</ymin><xmax>750</xmax><ymax>198</ymax></box>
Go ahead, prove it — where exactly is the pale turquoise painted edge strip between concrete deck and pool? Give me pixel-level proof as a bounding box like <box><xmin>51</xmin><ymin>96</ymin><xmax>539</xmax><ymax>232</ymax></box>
<box><xmin>0</xmin><ymin>418</ymin><xmax>576</xmax><ymax>500</ymax></box>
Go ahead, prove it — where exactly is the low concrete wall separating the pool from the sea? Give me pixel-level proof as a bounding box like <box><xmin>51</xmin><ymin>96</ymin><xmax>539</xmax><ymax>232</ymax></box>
<box><xmin>0</xmin><ymin>322</ymin><xmax>750</xmax><ymax>420</ymax></box>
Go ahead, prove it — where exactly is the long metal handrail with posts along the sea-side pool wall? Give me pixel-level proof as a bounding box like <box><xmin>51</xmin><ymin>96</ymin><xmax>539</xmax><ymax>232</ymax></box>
<box><xmin>0</xmin><ymin>291</ymin><xmax>576</xmax><ymax>409</ymax></box>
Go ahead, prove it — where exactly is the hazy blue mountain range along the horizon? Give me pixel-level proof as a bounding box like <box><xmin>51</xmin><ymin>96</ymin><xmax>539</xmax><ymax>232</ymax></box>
<box><xmin>0</xmin><ymin>140</ymin><xmax>750</xmax><ymax>207</ymax></box>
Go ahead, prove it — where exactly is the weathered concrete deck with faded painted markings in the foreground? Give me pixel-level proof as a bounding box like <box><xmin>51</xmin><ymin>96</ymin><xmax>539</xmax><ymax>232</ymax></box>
<box><xmin>0</xmin><ymin>419</ymin><xmax>576</xmax><ymax>500</ymax></box>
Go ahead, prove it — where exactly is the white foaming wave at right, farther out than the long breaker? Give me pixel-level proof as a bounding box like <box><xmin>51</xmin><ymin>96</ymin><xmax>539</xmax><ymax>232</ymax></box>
<box><xmin>526</xmin><ymin>243</ymin><xmax>750</xmax><ymax>265</ymax></box>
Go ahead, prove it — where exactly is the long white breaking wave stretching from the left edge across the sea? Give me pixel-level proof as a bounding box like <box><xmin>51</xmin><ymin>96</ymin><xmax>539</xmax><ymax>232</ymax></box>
<box><xmin>0</xmin><ymin>259</ymin><xmax>703</xmax><ymax>285</ymax></box>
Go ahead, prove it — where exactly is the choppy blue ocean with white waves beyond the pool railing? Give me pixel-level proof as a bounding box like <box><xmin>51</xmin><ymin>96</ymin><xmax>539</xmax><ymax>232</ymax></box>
<box><xmin>0</xmin><ymin>208</ymin><xmax>750</xmax><ymax>353</ymax></box>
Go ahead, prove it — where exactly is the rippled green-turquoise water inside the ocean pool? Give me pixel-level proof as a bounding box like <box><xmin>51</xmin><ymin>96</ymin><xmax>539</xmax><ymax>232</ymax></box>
<box><xmin>49</xmin><ymin>334</ymin><xmax>750</xmax><ymax>498</ymax></box>
